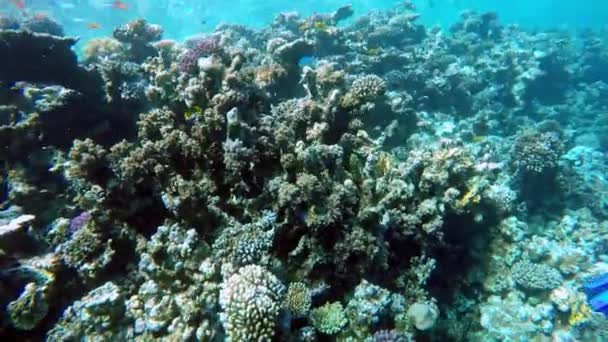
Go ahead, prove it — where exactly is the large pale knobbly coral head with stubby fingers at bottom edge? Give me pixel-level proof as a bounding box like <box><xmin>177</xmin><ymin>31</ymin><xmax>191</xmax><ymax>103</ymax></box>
<box><xmin>220</xmin><ymin>265</ymin><xmax>285</xmax><ymax>341</ymax></box>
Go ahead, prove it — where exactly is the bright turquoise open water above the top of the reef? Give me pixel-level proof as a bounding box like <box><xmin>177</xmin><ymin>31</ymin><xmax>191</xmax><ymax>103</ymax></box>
<box><xmin>0</xmin><ymin>0</ymin><xmax>608</xmax><ymax>43</ymax></box>
